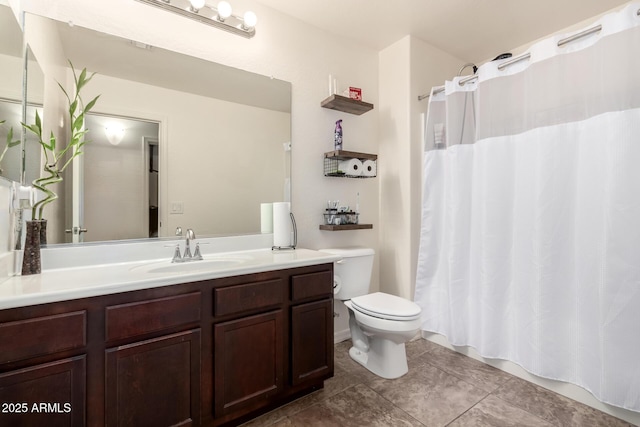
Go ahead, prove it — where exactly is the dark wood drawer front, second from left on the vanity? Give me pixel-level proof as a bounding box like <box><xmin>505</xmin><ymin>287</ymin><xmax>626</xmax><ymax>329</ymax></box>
<box><xmin>105</xmin><ymin>292</ymin><xmax>200</xmax><ymax>341</ymax></box>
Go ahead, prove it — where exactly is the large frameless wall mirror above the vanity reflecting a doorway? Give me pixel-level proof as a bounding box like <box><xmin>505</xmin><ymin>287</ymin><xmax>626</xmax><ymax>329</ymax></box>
<box><xmin>25</xmin><ymin>14</ymin><xmax>291</xmax><ymax>243</ymax></box>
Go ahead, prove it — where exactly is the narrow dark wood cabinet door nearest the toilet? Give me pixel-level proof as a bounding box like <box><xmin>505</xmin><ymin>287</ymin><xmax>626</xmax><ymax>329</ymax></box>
<box><xmin>291</xmin><ymin>299</ymin><xmax>333</xmax><ymax>385</ymax></box>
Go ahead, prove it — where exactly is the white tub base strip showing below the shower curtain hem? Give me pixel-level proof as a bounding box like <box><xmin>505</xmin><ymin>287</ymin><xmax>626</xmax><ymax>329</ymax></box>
<box><xmin>422</xmin><ymin>331</ymin><xmax>640</xmax><ymax>426</ymax></box>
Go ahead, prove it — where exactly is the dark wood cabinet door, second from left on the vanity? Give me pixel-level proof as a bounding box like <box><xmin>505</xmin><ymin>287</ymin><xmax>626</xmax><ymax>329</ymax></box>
<box><xmin>105</xmin><ymin>329</ymin><xmax>201</xmax><ymax>426</ymax></box>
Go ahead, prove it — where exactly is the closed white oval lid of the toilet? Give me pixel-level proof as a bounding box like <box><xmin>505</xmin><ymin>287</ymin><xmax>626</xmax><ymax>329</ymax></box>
<box><xmin>351</xmin><ymin>292</ymin><xmax>422</xmax><ymax>320</ymax></box>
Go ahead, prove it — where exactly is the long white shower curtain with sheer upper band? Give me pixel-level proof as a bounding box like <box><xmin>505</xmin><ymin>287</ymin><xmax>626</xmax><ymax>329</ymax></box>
<box><xmin>415</xmin><ymin>2</ymin><xmax>640</xmax><ymax>411</ymax></box>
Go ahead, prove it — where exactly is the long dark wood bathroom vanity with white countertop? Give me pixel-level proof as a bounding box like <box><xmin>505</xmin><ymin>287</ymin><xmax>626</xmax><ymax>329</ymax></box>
<box><xmin>0</xmin><ymin>249</ymin><xmax>334</xmax><ymax>426</ymax></box>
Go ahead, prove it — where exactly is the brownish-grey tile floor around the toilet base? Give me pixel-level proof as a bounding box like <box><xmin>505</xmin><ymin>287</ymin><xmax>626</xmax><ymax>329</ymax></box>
<box><xmin>244</xmin><ymin>339</ymin><xmax>632</xmax><ymax>427</ymax></box>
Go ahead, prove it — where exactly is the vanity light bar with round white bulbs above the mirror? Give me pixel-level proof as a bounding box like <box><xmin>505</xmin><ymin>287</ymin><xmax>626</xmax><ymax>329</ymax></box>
<box><xmin>136</xmin><ymin>0</ymin><xmax>258</xmax><ymax>39</ymax></box>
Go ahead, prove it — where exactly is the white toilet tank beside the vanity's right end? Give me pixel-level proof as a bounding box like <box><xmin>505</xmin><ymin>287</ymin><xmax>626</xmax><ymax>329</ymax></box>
<box><xmin>320</xmin><ymin>248</ymin><xmax>375</xmax><ymax>301</ymax></box>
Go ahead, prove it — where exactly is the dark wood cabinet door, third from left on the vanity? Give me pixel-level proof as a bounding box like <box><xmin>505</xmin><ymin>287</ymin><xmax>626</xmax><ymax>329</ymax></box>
<box><xmin>213</xmin><ymin>310</ymin><xmax>284</xmax><ymax>418</ymax></box>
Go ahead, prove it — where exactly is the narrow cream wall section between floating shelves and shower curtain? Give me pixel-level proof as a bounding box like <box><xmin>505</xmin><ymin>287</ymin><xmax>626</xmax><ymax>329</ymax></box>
<box><xmin>378</xmin><ymin>36</ymin><xmax>465</xmax><ymax>299</ymax></box>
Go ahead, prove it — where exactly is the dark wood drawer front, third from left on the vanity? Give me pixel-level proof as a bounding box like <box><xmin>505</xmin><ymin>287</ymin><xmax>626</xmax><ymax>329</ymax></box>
<box><xmin>213</xmin><ymin>279</ymin><xmax>283</xmax><ymax>316</ymax></box>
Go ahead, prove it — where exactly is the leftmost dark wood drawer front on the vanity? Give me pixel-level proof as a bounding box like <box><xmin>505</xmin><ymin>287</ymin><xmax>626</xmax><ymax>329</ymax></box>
<box><xmin>0</xmin><ymin>310</ymin><xmax>87</xmax><ymax>363</ymax></box>
